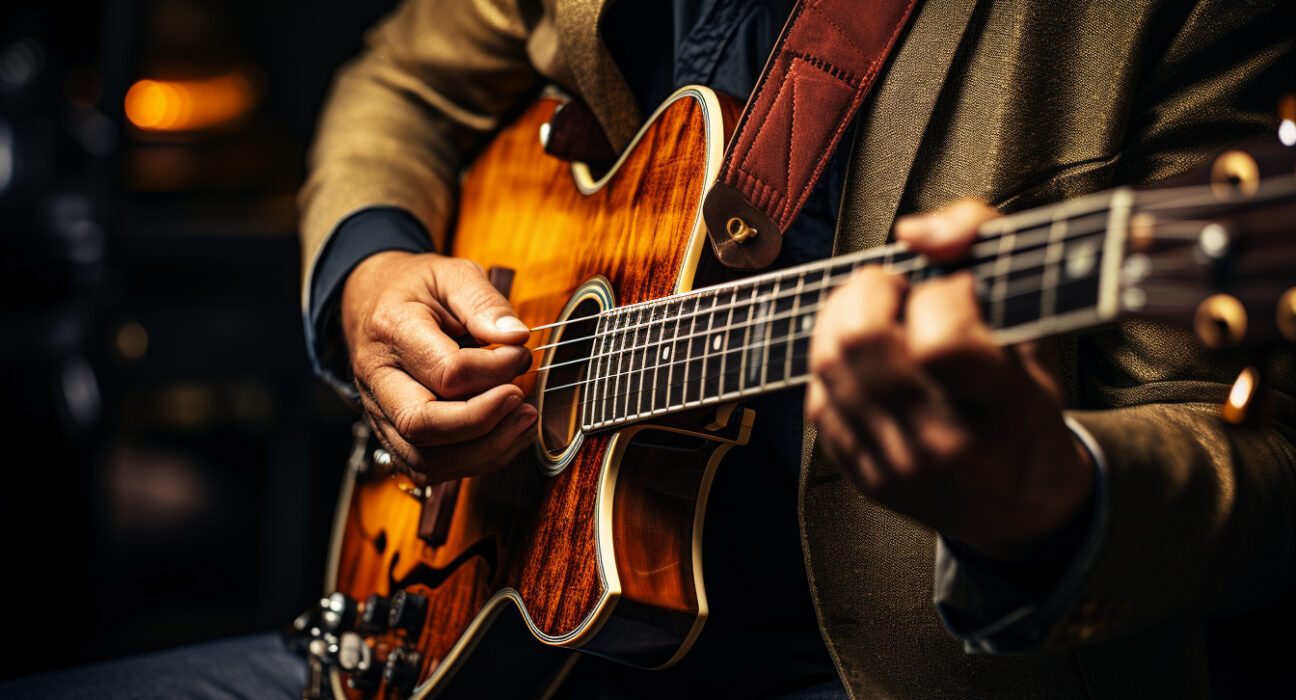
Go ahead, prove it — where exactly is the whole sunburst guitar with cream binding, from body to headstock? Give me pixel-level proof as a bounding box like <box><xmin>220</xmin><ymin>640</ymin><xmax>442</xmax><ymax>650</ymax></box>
<box><xmin>294</xmin><ymin>88</ymin><xmax>1296</xmax><ymax>699</ymax></box>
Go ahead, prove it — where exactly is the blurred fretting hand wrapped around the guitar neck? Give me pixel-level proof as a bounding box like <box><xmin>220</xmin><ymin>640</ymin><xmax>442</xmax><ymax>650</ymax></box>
<box><xmin>806</xmin><ymin>201</ymin><xmax>1094</xmax><ymax>559</ymax></box>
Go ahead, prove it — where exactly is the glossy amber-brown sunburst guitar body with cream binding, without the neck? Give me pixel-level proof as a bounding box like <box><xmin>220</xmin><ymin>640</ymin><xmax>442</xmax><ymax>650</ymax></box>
<box><xmin>327</xmin><ymin>88</ymin><xmax>753</xmax><ymax>699</ymax></box>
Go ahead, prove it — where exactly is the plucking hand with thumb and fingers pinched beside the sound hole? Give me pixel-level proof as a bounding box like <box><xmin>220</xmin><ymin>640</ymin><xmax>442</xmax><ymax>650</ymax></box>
<box><xmin>342</xmin><ymin>251</ymin><xmax>537</xmax><ymax>484</ymax></box>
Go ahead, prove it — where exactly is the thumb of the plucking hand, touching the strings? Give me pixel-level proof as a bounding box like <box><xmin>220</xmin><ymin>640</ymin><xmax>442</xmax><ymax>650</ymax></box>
<box><xmin>434</xmin><ymin>259</ymin><xmax>530</xmax><ymax>345</ymax></box>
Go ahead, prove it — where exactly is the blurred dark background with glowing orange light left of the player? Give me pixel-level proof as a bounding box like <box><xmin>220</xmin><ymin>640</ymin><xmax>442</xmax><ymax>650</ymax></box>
<box><xmin>0</xmin><ymin>0</ymin><xmax>393</xmax><ymax>678</ymax></box>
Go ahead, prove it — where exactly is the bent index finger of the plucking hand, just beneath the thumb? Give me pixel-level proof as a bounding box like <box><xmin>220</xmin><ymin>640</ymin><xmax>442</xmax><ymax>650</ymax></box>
<box><xmin>393</xmin><ymin>305</ymin><xmax>531</xmax><ymax>399</ymax></box>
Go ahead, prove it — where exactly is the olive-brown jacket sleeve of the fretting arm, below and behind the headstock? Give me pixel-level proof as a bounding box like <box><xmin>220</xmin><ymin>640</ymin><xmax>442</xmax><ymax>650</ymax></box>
<box><xmin>937</xmin><ymin>1</ymin><xmax>1296</xmax><ymax>651</ymax></box>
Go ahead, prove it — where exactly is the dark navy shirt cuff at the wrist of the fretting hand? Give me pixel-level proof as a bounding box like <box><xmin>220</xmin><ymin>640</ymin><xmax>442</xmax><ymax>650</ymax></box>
<box><xmin>934</xmin><ymin>417</ymin><xmax>1111</xmax><ymax>653</ymax></box>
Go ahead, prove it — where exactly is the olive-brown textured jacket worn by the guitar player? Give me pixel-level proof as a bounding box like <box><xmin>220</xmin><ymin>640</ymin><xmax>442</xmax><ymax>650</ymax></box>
<box><xmin>302</xmin><ymin>0</ymin><xmax>1296</xmax><ymax>697</ymax></box>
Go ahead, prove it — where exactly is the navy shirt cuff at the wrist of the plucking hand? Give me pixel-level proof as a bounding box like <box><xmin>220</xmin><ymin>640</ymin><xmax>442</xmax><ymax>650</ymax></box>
<box><xmin>302</xmin><ymin>206</ymin><xmax>434</xmax><ymax>398</ymax></box>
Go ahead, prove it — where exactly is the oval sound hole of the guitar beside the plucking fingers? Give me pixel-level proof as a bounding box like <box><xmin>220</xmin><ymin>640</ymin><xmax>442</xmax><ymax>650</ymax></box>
<box><xmin>539</xmin><ymin>298</ymin><xmax>603</xmax><ymax>461</ymax></box>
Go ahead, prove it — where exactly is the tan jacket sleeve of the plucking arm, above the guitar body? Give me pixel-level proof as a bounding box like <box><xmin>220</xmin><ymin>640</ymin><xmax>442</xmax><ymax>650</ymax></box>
<box><xmin>299</xmin><ymin>0</ymin><xmax>546</xmax><ymax>296</ymax></box>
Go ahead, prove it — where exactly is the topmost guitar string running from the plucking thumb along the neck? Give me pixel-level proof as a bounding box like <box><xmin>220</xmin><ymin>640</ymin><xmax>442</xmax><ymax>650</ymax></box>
<box><xmin>520</xmin><ymin>210</ymin><xmax>1109</xmax><ymax>351</ymax></box>
